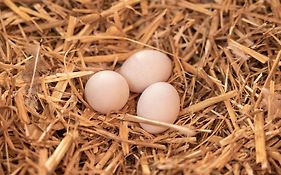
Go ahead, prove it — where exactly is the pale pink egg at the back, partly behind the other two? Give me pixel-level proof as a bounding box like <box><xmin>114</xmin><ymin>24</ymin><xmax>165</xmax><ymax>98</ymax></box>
<box><xmin>120</xmin><ymin>49</ymin><xmax>172</xmax><ymax>93</ymax></box>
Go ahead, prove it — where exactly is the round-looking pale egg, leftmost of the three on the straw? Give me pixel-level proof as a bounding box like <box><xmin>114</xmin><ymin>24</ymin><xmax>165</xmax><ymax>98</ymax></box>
<box><xmin>85</xmin><ymin>70</ymin><xmax>130</xmax><ymax>114</ymax></box>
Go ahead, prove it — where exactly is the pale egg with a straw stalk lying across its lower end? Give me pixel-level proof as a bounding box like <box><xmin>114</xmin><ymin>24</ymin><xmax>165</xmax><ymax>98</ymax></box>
<box><xmin>137</xmin><ymin>82</ymin><xmax>180</xmax><ymax>134</ymax></box>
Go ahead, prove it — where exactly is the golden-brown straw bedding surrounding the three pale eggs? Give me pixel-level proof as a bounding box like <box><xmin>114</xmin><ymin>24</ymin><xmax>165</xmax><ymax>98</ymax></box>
<box><xmin>0</xmin><ymin>0</ymin><xmax>281</xmax><ymax>175</ymax></box>
